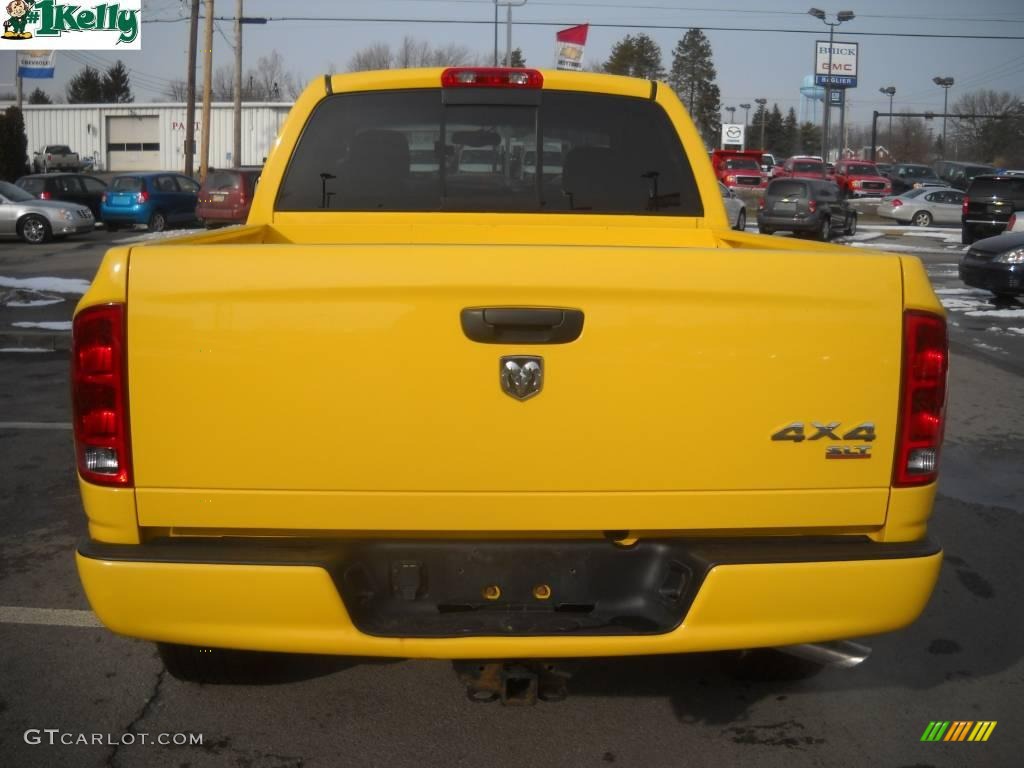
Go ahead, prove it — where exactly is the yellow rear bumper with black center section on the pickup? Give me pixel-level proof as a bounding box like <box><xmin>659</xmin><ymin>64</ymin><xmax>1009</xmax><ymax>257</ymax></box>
<box><xmin>77</xmin><ymin>537</ymin><xmax>942</xmax><ymax>658</ymax></box>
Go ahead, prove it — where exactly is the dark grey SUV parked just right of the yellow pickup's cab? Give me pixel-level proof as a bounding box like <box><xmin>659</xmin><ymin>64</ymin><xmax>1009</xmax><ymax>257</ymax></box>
<box><xmin>758</xmin><ymin>178</ymin><xmax>857</xmax><ymax>241</ymax></box>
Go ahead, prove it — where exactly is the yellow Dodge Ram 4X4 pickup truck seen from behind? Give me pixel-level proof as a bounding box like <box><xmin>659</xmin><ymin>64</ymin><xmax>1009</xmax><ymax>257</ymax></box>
<box><xmin>73</xmin><ymin>68</ymin><xmax>947</xmax><ymax>696</ymax></box>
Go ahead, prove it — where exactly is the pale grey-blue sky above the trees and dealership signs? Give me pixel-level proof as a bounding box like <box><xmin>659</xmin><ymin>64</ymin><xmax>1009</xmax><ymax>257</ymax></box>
<box><xmin>0</xmin><ymin>0</ymin><xmax>1024</xmax><ymax>128</ymax></box>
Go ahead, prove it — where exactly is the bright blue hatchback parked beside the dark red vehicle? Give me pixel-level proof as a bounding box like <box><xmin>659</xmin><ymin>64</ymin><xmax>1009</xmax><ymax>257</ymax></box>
<box><xmin>99</xmin><ymin>173</ymin><xmax>199</xmax><ymax>232</ymax></box>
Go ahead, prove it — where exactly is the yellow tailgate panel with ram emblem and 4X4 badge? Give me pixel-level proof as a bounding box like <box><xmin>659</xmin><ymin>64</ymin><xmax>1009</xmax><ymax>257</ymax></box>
<box><xmin>127</xmin><ymin>244</ymin><xmax>902</xmax><ymax>529</ymax></box>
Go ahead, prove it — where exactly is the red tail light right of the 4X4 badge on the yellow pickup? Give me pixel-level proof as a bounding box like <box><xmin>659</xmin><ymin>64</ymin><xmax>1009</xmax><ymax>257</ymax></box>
<box><xmin>893</xmin><ymin>311</ymin><xmax>949</xmax><ymax>485</ymax></box>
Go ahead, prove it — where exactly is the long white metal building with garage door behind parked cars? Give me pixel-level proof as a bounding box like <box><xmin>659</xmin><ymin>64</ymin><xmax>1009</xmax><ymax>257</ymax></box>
<box><xmin>14</xmin><ymin>102</ymin><xmax>292</xmax><ymax>171</ymax></box>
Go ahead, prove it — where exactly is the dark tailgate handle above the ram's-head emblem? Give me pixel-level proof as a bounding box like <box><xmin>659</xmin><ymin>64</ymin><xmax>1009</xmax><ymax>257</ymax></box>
<box><xmin>461</xmin><ymin>306</ymin><xmax>583</xmax><ymax>344</ymax></box>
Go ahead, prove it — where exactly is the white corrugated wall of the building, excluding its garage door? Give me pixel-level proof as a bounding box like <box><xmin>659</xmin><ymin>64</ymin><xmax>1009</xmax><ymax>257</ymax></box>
<box><xmin>24</xmin><ymin>103</ymin><xmax>292</xmax><ymax>171</ymax></box>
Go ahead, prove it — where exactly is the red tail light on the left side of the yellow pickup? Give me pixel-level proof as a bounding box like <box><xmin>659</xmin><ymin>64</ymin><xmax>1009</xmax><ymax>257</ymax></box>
<box><xmin>71</xmin><ymin>304</ymin><xmax>132</xmax><ymax>486</ymax></box>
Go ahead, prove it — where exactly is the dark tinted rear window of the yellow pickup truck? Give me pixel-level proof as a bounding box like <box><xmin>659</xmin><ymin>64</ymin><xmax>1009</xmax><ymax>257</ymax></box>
<box><xmin>276</xmin><ymin>88</ymin><xmax>703</xmax><ymax>216</ymax></box>
